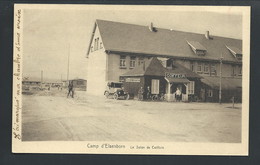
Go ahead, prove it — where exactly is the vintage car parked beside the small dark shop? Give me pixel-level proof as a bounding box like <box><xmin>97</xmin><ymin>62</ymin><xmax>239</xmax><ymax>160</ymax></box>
<box><xmin>104</xmin><ymin>82</ymin><xmax>129</xmax><ymax>100</ymax></box>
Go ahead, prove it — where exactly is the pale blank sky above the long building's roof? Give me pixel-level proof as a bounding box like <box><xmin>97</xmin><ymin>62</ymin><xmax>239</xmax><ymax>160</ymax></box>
<box><xmin>23</xmin><ymin>6</ymin><xmax>242</xmax><ymax>80</ymax></box>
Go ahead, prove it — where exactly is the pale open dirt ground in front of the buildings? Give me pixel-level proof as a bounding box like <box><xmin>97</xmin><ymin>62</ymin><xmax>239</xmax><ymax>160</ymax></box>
<box><xmin>22</xmin><ymin>90</ymin><xmax>241</xmax><ymax>143</ymax></box>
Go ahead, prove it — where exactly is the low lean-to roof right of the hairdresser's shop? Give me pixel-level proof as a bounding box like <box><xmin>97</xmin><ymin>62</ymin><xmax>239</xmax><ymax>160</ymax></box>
<box><xmin>201</xmin><ymin>77</ymin><xmax>242</xmax><ymax>90</ymax></box>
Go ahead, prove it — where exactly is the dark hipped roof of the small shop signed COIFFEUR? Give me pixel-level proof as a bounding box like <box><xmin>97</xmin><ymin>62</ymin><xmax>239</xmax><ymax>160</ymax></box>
<box><xmin>122</xmin><ymin>57</ymin><xmax>201</xmax><ymax>78</ymax></box>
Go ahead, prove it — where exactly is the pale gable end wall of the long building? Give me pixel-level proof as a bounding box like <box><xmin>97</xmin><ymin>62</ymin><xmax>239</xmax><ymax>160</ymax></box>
<box><xmin>86</xmin><ymin>28</ymin><xmax>107</xmax><ymax>95</ymax></box>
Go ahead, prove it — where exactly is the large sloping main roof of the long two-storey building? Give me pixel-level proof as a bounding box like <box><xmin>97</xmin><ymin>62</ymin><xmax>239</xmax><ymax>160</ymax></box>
<box><xmin>94</xmin><ymin>20</ymin><xmax>242</xmax><ymax>62</ymax></box>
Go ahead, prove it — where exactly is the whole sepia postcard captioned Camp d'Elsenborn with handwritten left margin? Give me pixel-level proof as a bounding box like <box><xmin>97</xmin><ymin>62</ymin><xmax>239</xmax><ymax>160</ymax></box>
<box><xmin>12</xmin><ymin>4</ymin><xmax>250</xmax><ymax>156</ymax></box>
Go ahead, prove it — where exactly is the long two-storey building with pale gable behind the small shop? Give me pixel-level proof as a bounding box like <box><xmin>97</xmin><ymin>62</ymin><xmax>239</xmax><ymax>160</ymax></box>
<box><xmin>87</xmin><ymin>20</ymin><xmax>242</xmax><ymax>101</ymax></box>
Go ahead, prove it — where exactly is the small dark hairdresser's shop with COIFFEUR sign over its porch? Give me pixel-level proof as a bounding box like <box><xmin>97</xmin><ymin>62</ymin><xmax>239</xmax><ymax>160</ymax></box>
<box><xmin>121</xmin><ymin>58</ymin><xmax>200</xmax><ymax>101</ymax></box>
